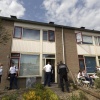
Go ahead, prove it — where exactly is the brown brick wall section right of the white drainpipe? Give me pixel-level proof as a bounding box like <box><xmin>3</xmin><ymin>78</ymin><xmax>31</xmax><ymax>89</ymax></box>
<box><xmin>64</xmin><ymin>29</ymin><xmax>79</xmax><ymax>80</ymax></box>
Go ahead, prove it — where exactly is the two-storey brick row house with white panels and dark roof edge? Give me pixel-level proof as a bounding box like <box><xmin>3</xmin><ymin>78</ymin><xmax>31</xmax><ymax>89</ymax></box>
<box><xmin>0</xmin><ymin>16</ymin><xmax>100</xmax><ymax>88</ymax></box>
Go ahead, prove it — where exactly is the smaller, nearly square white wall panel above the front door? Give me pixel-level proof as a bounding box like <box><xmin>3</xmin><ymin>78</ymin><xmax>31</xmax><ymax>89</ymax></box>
<box><xmin>43</xmin><ymin>42</ymin><xmax>56</xmax><ymax>53</ymax></box>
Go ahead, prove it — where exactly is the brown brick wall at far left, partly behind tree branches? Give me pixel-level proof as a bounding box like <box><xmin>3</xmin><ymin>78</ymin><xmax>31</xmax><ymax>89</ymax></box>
<box><xmin>0</xmin><ymin>20</ymin><xmax>14</xmax><ymax>89</ymax></box>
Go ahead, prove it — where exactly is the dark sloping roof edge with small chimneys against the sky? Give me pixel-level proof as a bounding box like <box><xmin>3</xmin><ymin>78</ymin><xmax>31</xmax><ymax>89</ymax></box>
<box><xmin>0</xmin><ymin>16</ymin><xmax>100</xmax><ymax>33</ymax></box>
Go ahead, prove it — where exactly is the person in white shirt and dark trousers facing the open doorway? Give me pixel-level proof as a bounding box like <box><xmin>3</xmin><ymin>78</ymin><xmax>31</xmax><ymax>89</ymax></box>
<box><xmin>43</xmin><ymin>62</ymin><xmax>52</xmax><ymax>87</ymax></box>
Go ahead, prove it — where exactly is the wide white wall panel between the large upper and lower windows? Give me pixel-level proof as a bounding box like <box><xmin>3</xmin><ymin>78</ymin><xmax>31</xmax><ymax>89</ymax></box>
<box><xmin>12</xmin><ymin>39</ymin><xmax>40</xmax><ymax>52</ymax></box>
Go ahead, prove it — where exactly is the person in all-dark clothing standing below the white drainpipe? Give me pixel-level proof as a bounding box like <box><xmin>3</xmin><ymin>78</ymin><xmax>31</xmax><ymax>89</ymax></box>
<box><xmin>58</xmin><ymin>61</ymin><xmax>70</xmax><ymax>92</ymax></box>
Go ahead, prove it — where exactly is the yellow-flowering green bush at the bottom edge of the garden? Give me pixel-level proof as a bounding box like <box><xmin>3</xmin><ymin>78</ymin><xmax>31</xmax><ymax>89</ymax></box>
<box><xmin>23</xmin><ymin>84</ymin><xmax>59</xmax><ymax>100</ymax></box>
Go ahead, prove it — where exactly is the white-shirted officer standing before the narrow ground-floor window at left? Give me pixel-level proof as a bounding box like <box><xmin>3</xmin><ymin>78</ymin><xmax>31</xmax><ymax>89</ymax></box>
<box><xmin>9</xmin><ymin>62</ymin><xmax>18</xmax><ymax>90</ymax></box>
